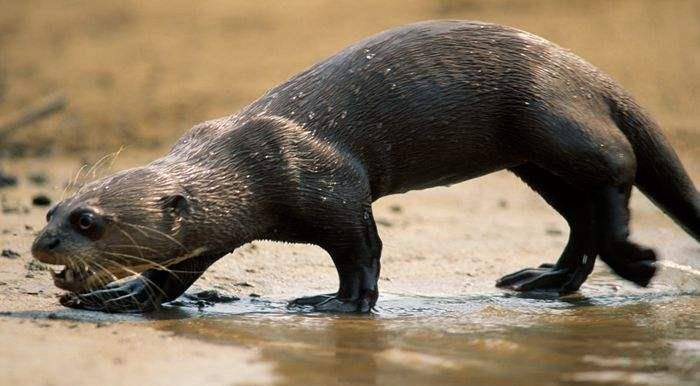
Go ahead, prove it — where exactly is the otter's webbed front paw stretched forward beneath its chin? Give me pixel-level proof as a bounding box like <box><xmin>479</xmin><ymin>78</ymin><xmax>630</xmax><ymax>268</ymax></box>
<box><xmin>59</xmin><ymin>277</ymin><xmax>164</xmax><ymax>313</ymax></box>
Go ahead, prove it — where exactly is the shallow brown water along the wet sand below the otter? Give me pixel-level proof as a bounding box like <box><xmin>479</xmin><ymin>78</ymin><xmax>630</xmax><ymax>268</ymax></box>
<box><xmin>156</xmin><ymin>268</ymin><xmax>700</xmax><ymax>385</ymax></box>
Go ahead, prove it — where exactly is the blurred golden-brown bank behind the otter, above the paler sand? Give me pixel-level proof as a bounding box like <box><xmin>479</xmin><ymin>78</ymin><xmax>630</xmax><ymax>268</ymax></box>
<box><xmin>0</xmin><ymin>0</ymin><xmax>700</xmax><ymax>156</ymax></box>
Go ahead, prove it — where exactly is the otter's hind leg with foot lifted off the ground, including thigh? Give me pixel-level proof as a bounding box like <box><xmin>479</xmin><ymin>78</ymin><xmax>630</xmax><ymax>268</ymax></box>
<box><xmin>516</xmin><ymin>119</ymin><xmax>656</xmax><ymax>286</ymax></box>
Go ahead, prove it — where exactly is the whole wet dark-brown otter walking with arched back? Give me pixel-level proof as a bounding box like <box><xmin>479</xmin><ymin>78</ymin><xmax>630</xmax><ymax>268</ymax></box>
<box><xmin>32</xmin><ymin>21</ymin><xmax>700</xmax><ymax>312</ymax></box>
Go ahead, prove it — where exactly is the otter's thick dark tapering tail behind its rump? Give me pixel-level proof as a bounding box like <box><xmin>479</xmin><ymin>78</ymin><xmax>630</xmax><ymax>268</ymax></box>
<box><xmin>611</xmin><ymin>96</ymin><xmax>700</xmax><ymax>238</ymax></box>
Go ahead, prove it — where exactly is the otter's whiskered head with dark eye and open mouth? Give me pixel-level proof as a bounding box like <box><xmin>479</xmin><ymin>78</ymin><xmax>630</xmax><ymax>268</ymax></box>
<box><xmin>32</xmin><ymin>166</ymin><xmax>190</xmax><ymax>293</ymax></box>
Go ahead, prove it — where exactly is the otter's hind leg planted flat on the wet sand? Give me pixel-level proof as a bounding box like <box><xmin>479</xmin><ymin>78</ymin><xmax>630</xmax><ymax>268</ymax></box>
<box><xmin>496</xmin><ymin>164</ymin><xmax>596</xmax><ymax>293</ymax></box>
